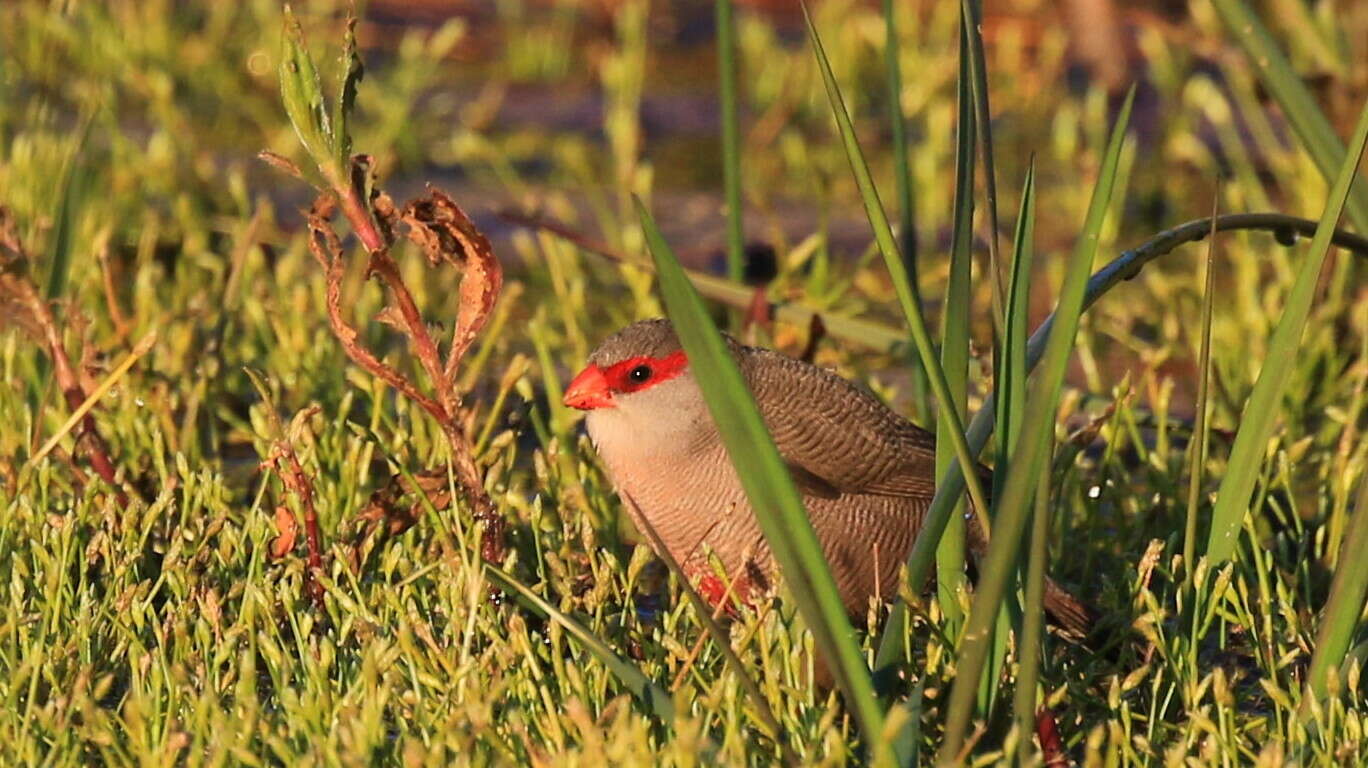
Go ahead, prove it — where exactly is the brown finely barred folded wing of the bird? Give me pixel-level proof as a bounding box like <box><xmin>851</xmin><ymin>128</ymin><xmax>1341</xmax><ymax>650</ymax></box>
<box><xmin>741</xmin><ymin>348</ymin><xmax>936</xmax><ymax>498</ymax></box>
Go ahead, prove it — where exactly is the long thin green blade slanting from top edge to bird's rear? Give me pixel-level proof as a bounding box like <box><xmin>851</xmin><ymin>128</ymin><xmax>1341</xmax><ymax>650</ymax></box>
<box><xmin>803</xmin><ymin>4</ymin><xmax>989</xmax><ymax>530</ymax></box>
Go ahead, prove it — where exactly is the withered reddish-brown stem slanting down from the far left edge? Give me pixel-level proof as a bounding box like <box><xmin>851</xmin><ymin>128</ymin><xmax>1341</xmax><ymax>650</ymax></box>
<box><xmin>0</xmin><ymin>207</ymin><xmax>129</xmax><ymax>507</ymax></box>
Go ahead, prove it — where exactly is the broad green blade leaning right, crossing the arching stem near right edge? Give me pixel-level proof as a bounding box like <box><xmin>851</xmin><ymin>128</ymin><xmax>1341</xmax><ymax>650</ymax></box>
<box><xmin>1207</xmin><ymin>103</ymin><xmax>1368</xmax><ymax>565</ymax></box>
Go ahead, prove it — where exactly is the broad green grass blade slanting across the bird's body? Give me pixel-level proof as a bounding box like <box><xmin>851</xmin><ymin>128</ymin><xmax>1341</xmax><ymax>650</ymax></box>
<box><xmin>636</xmin><ymin>200</ymin><xmax>886</xmax><ymax>754</ymax></box>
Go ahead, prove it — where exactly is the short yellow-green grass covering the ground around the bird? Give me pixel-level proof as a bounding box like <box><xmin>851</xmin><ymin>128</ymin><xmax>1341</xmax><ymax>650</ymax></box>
<box><xmin>0</xmin><ymin>0</ymin><xmax>1368</xmax><ymax>765</ymax></box>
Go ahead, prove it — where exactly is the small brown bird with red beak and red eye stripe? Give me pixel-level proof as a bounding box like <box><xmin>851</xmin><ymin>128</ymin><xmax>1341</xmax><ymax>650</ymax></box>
<box><xmin>564</xmin><ymin>319</ymin><xmax>1093</xmax><ymax>637</ymax></box>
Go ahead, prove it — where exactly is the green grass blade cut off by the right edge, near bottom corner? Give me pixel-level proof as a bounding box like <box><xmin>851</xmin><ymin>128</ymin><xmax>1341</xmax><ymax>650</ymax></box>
<box><xmin>1302</xmin><ymin>476</ymin><xmax>1368</xmax><ymax>715</ymax></box>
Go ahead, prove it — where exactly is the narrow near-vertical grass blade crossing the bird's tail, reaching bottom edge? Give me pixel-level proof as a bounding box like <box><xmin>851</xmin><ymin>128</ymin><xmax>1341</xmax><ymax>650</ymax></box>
<box><xmin>1012</xmin><ymin>453</ymin><xmax>1051</xmax><ymax>765</ymax></box>
